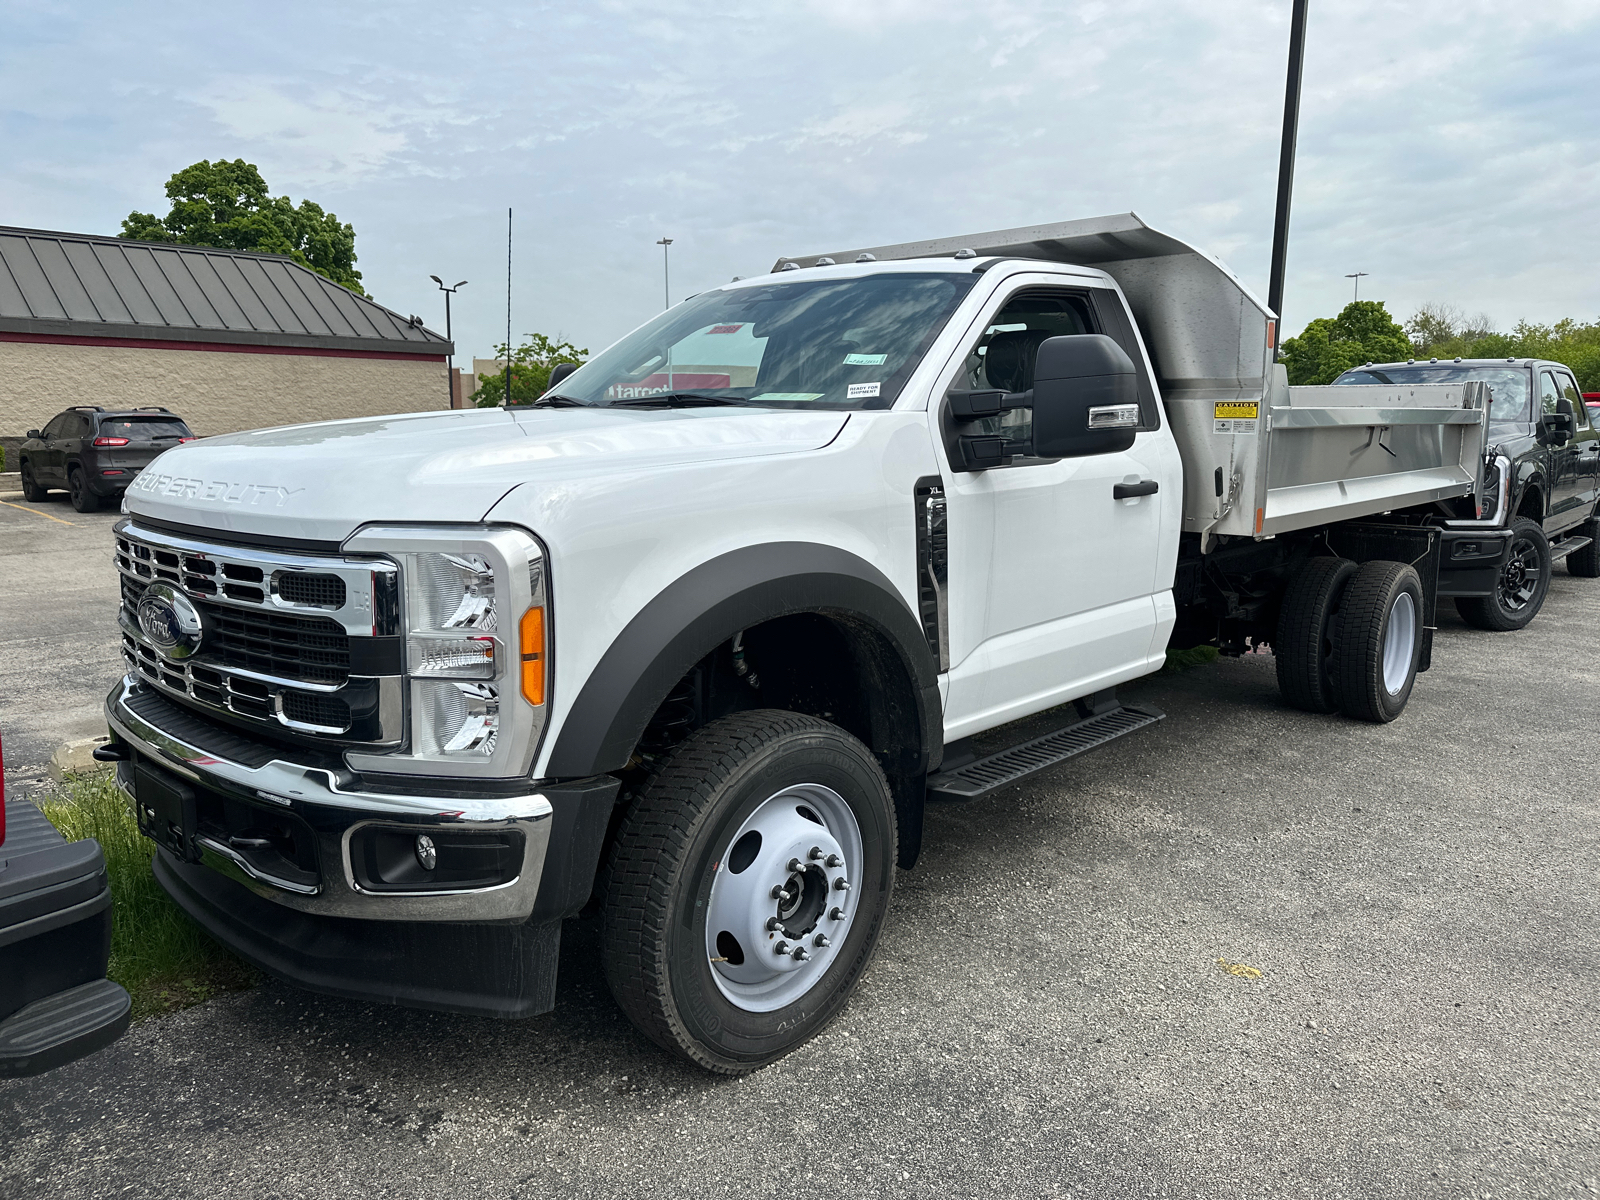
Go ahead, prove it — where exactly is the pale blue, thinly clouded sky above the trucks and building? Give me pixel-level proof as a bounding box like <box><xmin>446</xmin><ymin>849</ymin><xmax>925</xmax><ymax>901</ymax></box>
<box><xmin>0</xmin><ymin>0</ymin><xmax>1600</xmax><ymax>362</ymax></box>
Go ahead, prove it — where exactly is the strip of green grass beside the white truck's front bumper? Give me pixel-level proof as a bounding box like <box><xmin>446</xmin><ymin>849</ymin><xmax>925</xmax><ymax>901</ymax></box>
<box><xmin>42</xmin><ymin>774</ymin><xmax>259</xmax><ymax>1019</ymax></box>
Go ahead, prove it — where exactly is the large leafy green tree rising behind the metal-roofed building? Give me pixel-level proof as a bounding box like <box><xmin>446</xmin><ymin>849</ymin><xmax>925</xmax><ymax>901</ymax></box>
<box><xmin>122</xmin><ymin>158</ymin><xmax>366</xmax><ymax>296</ymax></box>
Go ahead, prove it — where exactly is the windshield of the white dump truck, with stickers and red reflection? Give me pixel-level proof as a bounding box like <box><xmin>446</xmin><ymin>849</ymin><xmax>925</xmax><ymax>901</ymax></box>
<box><xmin>534</xmin><ymin>274</ymin><xmax>978</xmax><ymax>408</ymax></box>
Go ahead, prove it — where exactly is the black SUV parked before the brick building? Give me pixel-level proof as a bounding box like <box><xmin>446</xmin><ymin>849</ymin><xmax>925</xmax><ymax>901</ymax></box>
<box><xmin>18</xmin><ymin>405</ymin><xmax>194</xmax><ymax>512</ymax></box>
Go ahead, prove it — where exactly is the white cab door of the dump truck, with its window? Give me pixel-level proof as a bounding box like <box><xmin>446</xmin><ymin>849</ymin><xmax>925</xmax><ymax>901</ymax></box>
<box><xmin>931</xmin><ymin>285</ymin><xmax>1182</xmax><ymax>738</ymax></box>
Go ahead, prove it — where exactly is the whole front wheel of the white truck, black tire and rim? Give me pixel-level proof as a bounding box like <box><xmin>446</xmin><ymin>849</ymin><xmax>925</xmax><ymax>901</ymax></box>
<box><xmin>602</xmin><ymin>710</ymin><xmax>896</xmax><ymax>1075</ymax></box>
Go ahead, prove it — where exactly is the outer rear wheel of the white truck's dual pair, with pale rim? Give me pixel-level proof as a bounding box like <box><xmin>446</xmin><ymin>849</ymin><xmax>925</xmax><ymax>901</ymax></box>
<box><xmin>1339</xmin><ymin>560</ymin><xmax>1424</xmax><ymax>723</ymax></box>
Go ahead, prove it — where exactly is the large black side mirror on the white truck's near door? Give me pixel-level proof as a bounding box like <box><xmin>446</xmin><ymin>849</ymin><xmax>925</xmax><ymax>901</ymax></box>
<box><xmin>1034</xmin><ymin>333</ymin><xmax>1139</xmax><ymax>458</ymax></box>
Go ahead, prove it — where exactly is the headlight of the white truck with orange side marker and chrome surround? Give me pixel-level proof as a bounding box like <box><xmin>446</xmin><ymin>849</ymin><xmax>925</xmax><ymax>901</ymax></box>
<box><xmin>344</xmin><ymin>526</ymin><xmax>550</xmax><ymax>778</ymax></box>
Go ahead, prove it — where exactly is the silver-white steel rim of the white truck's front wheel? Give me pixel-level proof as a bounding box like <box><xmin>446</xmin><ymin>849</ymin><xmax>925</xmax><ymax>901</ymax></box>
<box><xmin>706</xmin><ymin>784</ymin><xmax>862</xmax><ymax>1013</ymax></box>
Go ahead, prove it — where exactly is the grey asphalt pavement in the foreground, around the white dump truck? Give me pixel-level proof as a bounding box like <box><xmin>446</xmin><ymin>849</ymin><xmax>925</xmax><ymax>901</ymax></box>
<box><xmin>0</xmin><ymin>544</ymin><xmax>1600</xmax><ymax>1200</ymax></box>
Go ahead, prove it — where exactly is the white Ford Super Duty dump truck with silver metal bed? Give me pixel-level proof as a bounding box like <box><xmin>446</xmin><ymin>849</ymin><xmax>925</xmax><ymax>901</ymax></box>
<box><xmin>102</xmin><ymin>214</ymin><xmax>1507</xmax><ymax>1074</ymax></box>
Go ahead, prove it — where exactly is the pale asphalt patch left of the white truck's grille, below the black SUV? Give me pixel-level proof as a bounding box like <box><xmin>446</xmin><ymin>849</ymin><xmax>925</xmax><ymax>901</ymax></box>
<box><xmin>0</xmin><ymin>488</ymin><xmax>122</xmax><ymax>787</ymax></box>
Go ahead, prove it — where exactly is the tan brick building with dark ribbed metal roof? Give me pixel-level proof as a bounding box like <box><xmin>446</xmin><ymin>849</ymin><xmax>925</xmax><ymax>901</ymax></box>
<box><xmin>0</xmin><ymin>226</ymin><xmax>451</xmax><ymax>454</ymax></box>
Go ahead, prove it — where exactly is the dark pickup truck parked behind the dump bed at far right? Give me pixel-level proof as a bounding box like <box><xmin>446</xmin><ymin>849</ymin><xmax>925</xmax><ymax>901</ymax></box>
<box><xmin>1334</xmin><ymin>358</ymin><xmax>1600</xmax><ymax>630</ymax></box>
